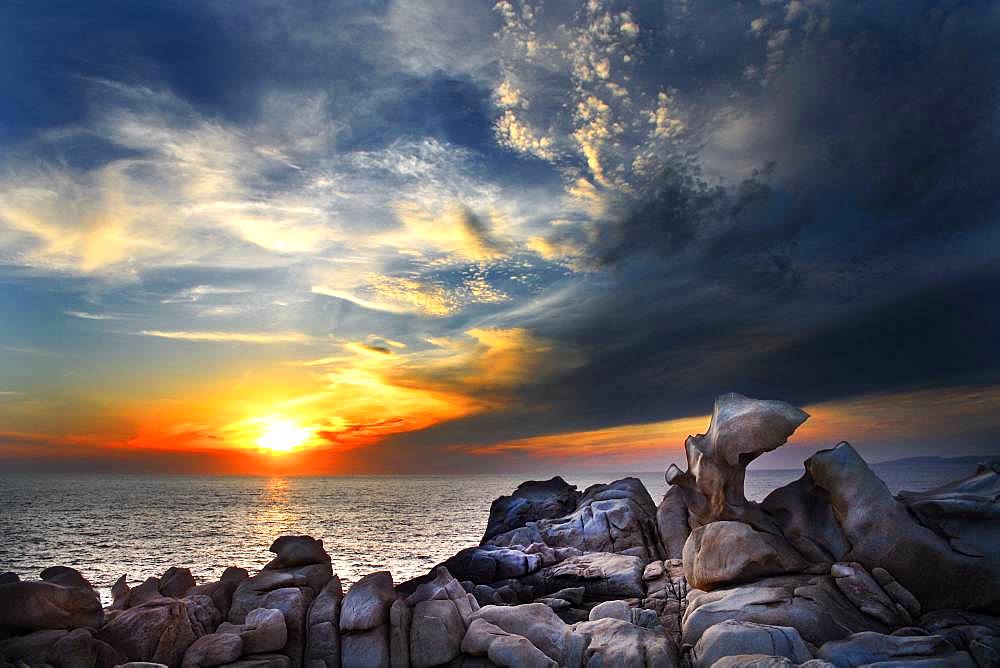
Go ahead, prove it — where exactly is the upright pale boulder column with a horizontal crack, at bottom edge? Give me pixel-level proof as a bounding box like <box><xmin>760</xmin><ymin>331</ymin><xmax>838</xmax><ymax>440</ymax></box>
<box><xmin>340</xmin><ymin>571</ymin><xmax>396</xmax><ymax>668</ymax></box>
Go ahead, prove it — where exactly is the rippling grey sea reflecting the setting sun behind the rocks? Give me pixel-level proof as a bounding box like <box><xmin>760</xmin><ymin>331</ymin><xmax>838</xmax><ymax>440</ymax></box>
<box><xmin>0</xmin><ymin>466</ymin><xmax>971</xmax><ymax>603</ymax></box>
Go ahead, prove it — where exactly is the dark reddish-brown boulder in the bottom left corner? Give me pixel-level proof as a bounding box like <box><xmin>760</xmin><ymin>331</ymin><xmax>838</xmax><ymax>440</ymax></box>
<box><xmin>0</xmin><ymin>629</ymin><xmax>125</xmax><ymax>668</ymax></box>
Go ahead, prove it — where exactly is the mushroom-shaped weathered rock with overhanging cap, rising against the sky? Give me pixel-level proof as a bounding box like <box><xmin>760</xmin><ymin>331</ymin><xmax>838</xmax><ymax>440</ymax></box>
<box><xmin>667</xmin><ymin>393</ymin><xmax>809</xmax><ymax>532</ymax></box>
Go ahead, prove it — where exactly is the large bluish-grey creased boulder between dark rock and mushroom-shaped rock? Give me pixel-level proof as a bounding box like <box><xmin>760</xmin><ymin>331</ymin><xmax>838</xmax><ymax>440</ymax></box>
<box><xmin>487</xmin><ymin>478</ymin><xmax>663</xmax><ymax>562</ymax></box>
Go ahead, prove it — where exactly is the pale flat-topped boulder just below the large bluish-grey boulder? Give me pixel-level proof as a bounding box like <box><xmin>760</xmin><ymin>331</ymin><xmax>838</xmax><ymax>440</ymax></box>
<box><xmin>540</xmin><ymin>552</ymin><xmax>646</xmax><ymax>600</ymax></box>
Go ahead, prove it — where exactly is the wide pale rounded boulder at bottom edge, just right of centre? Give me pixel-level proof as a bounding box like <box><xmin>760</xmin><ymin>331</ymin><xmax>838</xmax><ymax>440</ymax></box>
<box><xmin>567</xmin><ymin>618</ymin><xmax>678</xmax><ymax>668</ymax></box>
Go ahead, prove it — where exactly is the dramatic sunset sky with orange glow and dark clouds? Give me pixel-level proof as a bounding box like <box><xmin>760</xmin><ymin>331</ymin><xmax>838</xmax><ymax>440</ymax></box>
<box><xmin>0</xmin><ymin>0</ymin><xmax>1000</xmax><ymax>475</ymax></box>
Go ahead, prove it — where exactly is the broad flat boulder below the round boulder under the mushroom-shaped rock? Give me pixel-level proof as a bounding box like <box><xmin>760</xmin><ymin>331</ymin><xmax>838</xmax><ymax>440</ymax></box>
<box><xmin>682</xmin><ymin>575</ymin><xmax>887</xmax><ymax>645</ymax></box>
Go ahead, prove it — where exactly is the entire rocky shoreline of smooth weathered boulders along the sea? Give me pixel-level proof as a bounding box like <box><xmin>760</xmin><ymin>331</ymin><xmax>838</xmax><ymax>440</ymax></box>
<box><xmin>0</xmin><ymin>394</ymin><xmax>1000</xmax><ymax>668</ymax></box>
